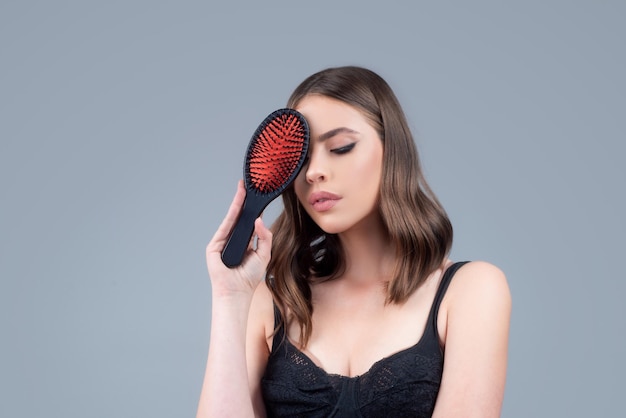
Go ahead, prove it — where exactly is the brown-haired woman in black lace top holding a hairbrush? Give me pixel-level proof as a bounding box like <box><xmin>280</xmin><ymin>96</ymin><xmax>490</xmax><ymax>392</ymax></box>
<box><xmin>198</xmin><ymin>67</ymin><xmax>511</xmax><ymax>418</ymax></box>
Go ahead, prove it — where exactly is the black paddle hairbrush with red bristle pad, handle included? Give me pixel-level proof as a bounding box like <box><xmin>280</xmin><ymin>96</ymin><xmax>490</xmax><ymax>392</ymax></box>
<box><xmin>222</xmin><ymin>109</ymin><xmax>309</xmax><ymax>267</ymax></box>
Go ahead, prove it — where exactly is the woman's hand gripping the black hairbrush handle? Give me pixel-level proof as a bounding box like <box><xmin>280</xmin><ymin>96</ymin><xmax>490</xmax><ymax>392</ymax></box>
<box><xmin>206</xmin><ymin>180</ymin><xmax>272</xmax><ymax>297</ymax></box>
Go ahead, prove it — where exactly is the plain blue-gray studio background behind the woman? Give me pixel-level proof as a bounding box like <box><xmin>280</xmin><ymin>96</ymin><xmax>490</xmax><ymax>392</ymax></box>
<box><xmin>0</xmin><ymin>0</ymin><xmax>626</xmax><ymax>418</ymax></box>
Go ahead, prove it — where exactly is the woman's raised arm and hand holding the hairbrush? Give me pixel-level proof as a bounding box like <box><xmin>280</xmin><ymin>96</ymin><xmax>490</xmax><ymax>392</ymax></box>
<box><xmin>197</xmin><ymin>182</ymin><xmax>272</xmax><ymax>418</ymax></box>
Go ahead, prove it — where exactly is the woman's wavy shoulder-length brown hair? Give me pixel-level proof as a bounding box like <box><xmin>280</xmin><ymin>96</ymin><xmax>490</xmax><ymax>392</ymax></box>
<box><xmin>267</xmin><ymin>66</ymin><xmax>452</xmax><ymax>347</ymax></box>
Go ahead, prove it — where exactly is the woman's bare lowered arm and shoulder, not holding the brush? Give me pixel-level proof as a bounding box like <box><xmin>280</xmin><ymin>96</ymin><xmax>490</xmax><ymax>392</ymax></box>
<box><xmin>433</xmin><ymin>262</ymin><xmax>511</xmax><ymax>418</ymax></box>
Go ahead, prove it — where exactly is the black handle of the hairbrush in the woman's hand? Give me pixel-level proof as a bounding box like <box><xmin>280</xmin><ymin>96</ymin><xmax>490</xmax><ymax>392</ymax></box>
<box><xmin>222</xmin><ymin>191</ymin><xmax>270</xmax><ymax>267</ymax></box>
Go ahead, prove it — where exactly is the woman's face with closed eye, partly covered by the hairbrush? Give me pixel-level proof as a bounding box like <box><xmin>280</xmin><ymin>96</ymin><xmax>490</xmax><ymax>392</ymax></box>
<box><xmin>294</xmin><ymin>95</ymin><xmax>383</xmax><ymax>234</ymax></box>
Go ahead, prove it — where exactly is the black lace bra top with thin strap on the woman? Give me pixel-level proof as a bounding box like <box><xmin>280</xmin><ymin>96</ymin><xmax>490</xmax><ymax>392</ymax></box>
<box><xmin>261</xmin><ymin>262</ymin><xmax>466</xmax><ymax>418</ymax></box>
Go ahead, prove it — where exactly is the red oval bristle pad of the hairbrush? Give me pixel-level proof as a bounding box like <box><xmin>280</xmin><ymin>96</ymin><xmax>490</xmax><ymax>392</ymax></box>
<box><xmin>248</xmin><ymin>114</ymin><xmax>306</xmax><ymax>193</ymax></box>
